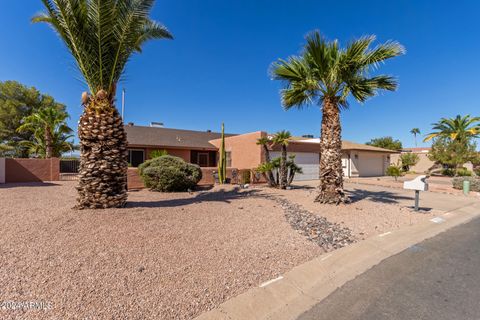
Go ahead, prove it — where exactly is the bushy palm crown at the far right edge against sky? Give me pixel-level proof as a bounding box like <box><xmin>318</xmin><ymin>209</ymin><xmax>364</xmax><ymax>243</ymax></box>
<box><xmin>423</xmin><ymin>114</ymin><xmax>480</xmax><ymax>144</ymax></box>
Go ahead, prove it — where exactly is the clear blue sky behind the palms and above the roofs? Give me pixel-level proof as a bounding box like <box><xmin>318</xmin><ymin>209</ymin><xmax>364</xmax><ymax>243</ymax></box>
<box><xmin>0</xmin><ymin>0</ymin><xmax>480</xmax><ymax>146</ymax></box>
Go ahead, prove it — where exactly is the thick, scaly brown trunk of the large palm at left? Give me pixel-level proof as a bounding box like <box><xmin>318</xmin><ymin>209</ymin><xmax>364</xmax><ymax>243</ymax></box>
<box><xmin>77</xmin><ymin>94</ymin><xmax>128</xmax><ymax>209</ymax></box>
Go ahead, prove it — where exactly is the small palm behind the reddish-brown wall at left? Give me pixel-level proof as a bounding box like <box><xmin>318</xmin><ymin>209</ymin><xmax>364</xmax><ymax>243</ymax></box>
<box><xmin>17</xmin><ymin>107</ymin><xmax>73</xmax><ymax>158</ymax></box>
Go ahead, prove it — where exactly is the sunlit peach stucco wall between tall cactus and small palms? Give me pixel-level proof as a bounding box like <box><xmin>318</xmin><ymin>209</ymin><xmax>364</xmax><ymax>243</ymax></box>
<box><xmin>210</xmin><ymin>131</ymin><xmax>267</xmax><ymax>170</ymax></box>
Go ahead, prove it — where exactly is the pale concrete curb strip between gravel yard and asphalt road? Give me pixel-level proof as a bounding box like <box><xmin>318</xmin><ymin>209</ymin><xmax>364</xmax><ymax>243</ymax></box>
<box><xmin>195</xmin><ymin>204</ymin><xmax>480</xmax><ymax>320</ymax></box>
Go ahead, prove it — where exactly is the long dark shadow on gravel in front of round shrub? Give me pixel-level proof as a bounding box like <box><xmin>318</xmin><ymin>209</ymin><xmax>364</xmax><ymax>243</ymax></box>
<box><xmin>126</xmin><ymin>188</ymin><xmax>260</xmax><ymax>208</ymax></box>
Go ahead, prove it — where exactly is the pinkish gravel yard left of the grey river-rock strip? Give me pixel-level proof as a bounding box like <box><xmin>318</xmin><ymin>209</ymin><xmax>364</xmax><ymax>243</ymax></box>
<box><xmin>0</xmin><ymin>182</ymin><xmax>324</xmax><ymax>319</ymax></box>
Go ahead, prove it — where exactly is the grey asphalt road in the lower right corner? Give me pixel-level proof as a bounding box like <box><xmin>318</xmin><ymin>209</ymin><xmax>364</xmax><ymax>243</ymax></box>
<box><xmin>298</xmin><ymin>219</ymin><xmax>480</xmax><ymax>320</ymax></box>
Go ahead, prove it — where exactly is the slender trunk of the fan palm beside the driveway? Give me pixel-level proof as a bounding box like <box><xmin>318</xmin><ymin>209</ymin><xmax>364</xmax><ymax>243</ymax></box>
<box><xmin>315</xmin><ymin>98</ymin><xmax>349</xmax><ymax>204</ymax></box>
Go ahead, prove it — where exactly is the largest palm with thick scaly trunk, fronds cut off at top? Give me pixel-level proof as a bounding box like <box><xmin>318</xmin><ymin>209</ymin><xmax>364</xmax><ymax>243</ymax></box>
<box><xmin>32</xmin><ymin>0</ymin><xmax>172</xmax><ymax>209</ymax></box>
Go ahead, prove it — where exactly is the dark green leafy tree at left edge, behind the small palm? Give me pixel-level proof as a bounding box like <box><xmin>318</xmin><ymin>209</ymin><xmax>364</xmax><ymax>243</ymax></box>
<box><xmin>0</xmin><ymin>81</ymin><xmax>66</xmax><ymax>158</ymax></box>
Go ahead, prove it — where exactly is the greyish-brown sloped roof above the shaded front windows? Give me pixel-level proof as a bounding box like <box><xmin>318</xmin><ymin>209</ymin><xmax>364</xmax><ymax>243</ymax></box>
<box><xmin>125</xmin><ymin>125</ymin><xmax>233</xmax><ymax>150</ymax></box>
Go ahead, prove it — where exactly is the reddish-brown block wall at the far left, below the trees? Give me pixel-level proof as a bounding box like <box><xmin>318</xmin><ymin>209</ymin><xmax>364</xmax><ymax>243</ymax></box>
<box><xmin>5</xmin><ymin>158</ymin><xmax>60</xmax><ymax>183</ymax></box>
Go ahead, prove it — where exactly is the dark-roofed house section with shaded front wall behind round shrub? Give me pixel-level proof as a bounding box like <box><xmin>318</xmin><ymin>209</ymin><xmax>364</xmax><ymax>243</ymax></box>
<box><xmin>125</xmin><ymin>124</ymin><xmax>235</xmax><ymax>167</ymax></box>
